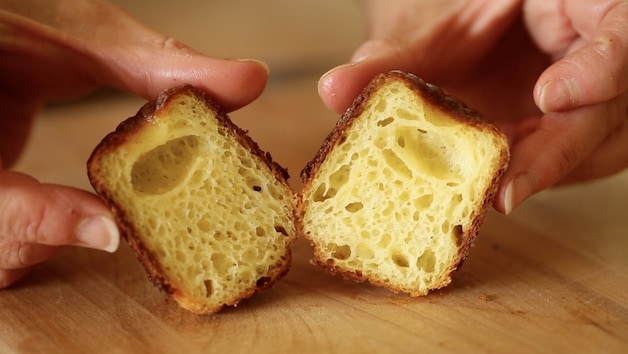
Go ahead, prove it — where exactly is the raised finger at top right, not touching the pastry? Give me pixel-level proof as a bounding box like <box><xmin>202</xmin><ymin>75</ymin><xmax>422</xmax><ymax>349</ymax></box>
<box><xmin>534</xmin><ymin>0</ymin><xmax>628</xmax><ymax>112</ymax></box>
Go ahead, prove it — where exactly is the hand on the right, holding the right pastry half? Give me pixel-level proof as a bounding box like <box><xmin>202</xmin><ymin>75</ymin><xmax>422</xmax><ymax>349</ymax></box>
<box><xmin>319</xmin><ymin>0</ymin><xmax>628</xmax><ymax>213</ymax></box>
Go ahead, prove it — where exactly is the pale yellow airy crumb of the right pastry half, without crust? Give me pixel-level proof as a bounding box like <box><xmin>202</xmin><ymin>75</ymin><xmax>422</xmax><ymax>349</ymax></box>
<box><xmin>303</xmin><ymin>82</ymin><xmax>503</xmax><ymax>295</ymax></box>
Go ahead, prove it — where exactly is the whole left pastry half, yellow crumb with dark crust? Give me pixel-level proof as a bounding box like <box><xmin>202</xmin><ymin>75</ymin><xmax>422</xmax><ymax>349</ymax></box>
<box><xmin>88</xmin><ymin>86</ymin><xmax>297</xmax><ymax>313</ymax></box>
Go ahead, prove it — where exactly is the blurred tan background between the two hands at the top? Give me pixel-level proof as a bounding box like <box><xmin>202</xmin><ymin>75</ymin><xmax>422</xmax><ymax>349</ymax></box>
<box><xmin>113</xmin><ymin>0</ymin><xmax>364</xmax><ymax>79</ymax></box>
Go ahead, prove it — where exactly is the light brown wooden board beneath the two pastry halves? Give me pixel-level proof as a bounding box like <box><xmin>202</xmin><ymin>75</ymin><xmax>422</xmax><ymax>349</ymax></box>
<box><xmin>0</xmin><ymin>78</ymin><xmax>628</xmax><ymax>353</ymax></box>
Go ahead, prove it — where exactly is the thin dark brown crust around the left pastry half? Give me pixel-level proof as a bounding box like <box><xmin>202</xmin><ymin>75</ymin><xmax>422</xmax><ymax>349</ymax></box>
<box><xmin>87</xmin><ymin>85</ymin><xmax>296</xmax><ymax>313</ymax></box>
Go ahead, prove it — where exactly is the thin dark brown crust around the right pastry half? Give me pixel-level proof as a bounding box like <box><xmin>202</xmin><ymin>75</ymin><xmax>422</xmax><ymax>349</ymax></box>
<box><xmin>297</xmin><ymin>70</ymin><xmax>510</xmax><ymax>296</ymax></box>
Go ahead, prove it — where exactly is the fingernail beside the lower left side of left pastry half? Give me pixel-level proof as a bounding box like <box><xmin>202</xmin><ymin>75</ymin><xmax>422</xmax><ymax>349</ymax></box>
<box><xmin>75</xmin><ymin>216</ymin><xmax>120</xmax><ymax>253</ymax></box>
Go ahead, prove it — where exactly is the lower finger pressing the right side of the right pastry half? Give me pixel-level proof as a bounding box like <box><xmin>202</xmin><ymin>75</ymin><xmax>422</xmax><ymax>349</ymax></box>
<box><xmin>495</xmin><ymin>94</ymin><xmax>627</xmax><ymax>213</ymax></box>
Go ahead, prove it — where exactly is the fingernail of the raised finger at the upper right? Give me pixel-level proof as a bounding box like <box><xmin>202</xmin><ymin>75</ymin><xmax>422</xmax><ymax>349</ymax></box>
<box><xmin>539</xmin><ymin>79</ymin><xmax>580</xmax><ymax>113</ymax></box>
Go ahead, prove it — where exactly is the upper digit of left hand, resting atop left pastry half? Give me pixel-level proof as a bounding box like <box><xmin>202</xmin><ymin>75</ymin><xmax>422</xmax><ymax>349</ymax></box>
<box><xmin>0</xmin><ymin>0</ymin><xmax>268</xmax><ymax>111</ymax></box>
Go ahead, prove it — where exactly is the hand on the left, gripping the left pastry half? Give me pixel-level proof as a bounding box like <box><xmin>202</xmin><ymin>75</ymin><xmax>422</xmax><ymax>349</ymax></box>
<box><xmin>0</xmin><ymin>0</ymin><xmax>268</xmax><ymax>288</ymax></box>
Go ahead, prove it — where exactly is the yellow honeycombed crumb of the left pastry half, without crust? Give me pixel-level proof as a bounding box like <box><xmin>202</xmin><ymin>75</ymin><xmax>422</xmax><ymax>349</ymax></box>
<box><xmin>96</xmin><ymin>95</ymin><xmax>296</xmax><ymax>308</ymax></box>
